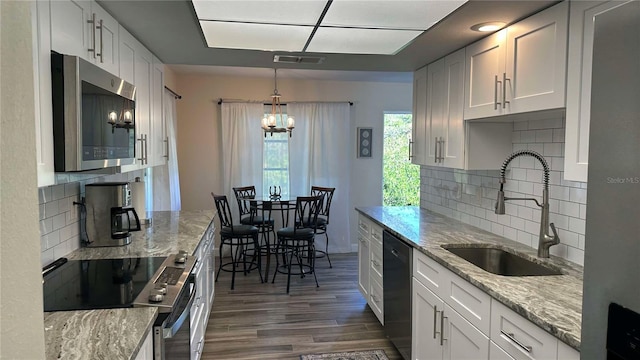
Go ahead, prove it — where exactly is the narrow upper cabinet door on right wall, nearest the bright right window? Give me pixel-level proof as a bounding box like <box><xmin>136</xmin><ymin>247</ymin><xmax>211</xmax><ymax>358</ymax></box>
<box><xmin>409</xmin><ymin>66</ymin><xmax>427</xmax><ymax>165</ymax></box>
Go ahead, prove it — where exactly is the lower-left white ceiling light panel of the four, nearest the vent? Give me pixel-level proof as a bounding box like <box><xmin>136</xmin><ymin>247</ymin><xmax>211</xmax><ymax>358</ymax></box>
<box><xmin>200</xmin><ymin>21</ymin><xmax>313</xmax><ymax>51</ymax></box>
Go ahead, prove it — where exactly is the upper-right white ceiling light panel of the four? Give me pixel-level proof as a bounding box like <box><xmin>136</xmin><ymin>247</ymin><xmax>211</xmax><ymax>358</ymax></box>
<box><xmin>322</xmin><ymin>0</ymin><xmax>466</xmax><ymax>30</ymax></box>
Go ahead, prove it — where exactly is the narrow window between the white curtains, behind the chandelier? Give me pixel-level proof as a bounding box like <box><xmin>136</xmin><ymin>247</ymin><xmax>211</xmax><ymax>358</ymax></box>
<box><xmin>262</xmin><ymin>105</ymin><xmax>289</xmax><ymax>196</ymax></box>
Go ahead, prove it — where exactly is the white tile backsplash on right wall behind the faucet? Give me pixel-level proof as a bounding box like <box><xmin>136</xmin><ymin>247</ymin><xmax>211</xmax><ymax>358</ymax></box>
<box><xmin>420</xmin><ymin>117</ymin><xmax>587</xmax><ymax>265</ymax></box>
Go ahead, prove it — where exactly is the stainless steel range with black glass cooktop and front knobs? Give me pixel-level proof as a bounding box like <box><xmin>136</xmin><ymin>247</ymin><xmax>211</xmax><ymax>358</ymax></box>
<box><xmin>43</xmin><ymin>251</ymin><xmax>197</xmax><ymax>360</ymax></box>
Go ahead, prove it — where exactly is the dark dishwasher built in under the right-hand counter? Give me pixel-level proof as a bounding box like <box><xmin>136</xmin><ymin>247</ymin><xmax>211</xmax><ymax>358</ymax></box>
<box><xmin>382</xmin><ymin>231</ymin><xmax>412</xmax><ymax>360</ymax></box>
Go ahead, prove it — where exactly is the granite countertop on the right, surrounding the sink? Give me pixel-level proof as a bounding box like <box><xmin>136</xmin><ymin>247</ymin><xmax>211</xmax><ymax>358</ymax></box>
<box><xmin>356</xmin><ymin>206</ymin><xmax>583</xmax><ymax>350</ymax></box>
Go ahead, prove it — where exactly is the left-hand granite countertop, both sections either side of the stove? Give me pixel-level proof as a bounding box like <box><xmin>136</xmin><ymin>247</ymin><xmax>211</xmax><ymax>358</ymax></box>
<box><xmin>44</xmin><ymin>210</ymin><xmax>215</xmax><ymax>359</ymax></box>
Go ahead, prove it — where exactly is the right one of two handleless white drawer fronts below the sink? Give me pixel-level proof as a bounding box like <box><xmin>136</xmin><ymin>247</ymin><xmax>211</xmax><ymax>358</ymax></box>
<box><xmin>442</xmin><ymin>270</ymin><xmax>491</xmax><ymax>334</ymax></box>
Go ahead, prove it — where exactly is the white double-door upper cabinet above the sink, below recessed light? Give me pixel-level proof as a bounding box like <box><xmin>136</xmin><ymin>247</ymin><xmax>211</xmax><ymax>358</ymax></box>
<box><xmin>464</xmin><ymin>1</ymin><xmax>569</xmax><ymax>119</ymax></box>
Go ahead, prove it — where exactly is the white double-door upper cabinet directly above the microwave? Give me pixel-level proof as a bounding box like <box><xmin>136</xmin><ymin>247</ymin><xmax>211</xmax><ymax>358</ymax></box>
<box><xmin>50</xmin><ymin>0</ymin><xmax>120</xmax><ymax>75</ymax></box>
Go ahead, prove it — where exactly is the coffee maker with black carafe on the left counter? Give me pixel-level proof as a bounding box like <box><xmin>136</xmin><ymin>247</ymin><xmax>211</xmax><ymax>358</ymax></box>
<box><xmin>84</xmin><ymin>182</ymin><xmax>140</xmax><ymax>247</ymax></box>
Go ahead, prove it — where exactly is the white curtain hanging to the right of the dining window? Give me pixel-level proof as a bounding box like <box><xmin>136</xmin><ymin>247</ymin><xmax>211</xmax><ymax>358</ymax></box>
<box><xmin>287</xmin><ymin>103</ymin><xmax>352</xmax><ymax>253</ymax></box>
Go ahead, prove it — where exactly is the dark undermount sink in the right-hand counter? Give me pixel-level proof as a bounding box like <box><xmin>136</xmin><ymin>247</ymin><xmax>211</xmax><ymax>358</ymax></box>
<box><xmin>443</xmin><ymin>246</ymin><xmax>562</xmax><ymax>276</ymax></box>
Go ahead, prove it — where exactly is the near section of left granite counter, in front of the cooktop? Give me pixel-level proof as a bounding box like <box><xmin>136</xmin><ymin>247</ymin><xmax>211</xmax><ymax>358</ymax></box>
<box><xmin>44</xmin><ymin>307</ymin><xmax>158</xmax><ymax>360</ymax></box>
